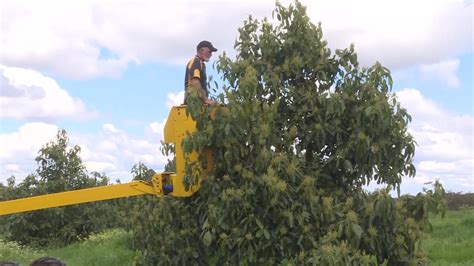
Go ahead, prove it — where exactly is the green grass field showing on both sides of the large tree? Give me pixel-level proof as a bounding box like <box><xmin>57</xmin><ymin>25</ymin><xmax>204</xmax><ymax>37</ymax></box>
<box><xmin>0</xmin><ymin>209</ymin><xmax>474</xmax><ymax>266</ymax></box>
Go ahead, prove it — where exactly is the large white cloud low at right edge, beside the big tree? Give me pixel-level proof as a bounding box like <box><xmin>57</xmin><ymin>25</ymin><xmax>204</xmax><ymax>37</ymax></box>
<box><xmin>397</xmin><ymin>89</ymin><xmax>474</xmax><ymax>191</ymax></box>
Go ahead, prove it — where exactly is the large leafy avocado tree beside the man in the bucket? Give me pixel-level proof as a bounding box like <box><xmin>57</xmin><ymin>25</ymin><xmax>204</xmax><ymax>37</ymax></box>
<box><xmin>130</xmin><ymin>2</ymin><xmax>443</xmax><ymax>265</ymax></box>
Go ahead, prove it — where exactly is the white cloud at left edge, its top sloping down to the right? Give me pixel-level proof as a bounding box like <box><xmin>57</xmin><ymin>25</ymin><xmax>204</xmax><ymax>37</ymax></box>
<box><xmin>0</xmin><ymin>65</ymin><xmax>94</xmax><ymax>119</ymax></box>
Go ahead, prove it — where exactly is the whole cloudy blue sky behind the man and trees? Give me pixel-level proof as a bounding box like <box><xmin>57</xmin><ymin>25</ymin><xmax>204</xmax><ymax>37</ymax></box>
<box><xmin>0</xmin><ymin>0</ymin><xmax>474</xmax><ymax>194</ymax></box>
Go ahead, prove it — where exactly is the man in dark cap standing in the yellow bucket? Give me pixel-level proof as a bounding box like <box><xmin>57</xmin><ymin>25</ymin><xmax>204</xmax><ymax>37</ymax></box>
<box><xmin>184</xmin><ymin>41</ymin><xmax>217</xmax><ymax>105</ymax></box>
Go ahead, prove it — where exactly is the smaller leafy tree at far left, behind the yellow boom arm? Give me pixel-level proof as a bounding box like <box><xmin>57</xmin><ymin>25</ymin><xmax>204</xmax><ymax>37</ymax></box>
<box><xmin>0</xmin><ymin>130</ymin><xmax>122</xmax><ymax>247</ymax></box>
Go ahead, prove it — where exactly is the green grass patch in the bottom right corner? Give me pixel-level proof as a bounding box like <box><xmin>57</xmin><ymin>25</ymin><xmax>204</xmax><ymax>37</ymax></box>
<box><xmin>423</xmin><ymin>208</ymin><xmax>474</xmax><ymax>265</ymax></box>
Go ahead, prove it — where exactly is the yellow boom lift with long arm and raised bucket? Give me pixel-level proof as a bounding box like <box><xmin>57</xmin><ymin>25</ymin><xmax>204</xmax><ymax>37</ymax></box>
<box><xmin>0</xmin><ymin>105</ymin><xmax>213</xmax><ymax>216</ymax></box>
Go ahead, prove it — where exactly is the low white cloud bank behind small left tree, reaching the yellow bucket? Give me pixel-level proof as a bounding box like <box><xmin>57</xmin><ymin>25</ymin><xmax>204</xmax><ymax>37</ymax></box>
<box><xmin>0</xmin><ymin>122</ymin><xmax>167</xmax><ymax>185</ymax></box>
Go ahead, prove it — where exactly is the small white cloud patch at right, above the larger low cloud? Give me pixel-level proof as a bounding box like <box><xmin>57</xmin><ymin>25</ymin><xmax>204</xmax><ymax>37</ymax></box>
<box><xmin>420</xmin><ymin>59</ymin><xmax>460</xmax><ymax>88</ymax></box>
